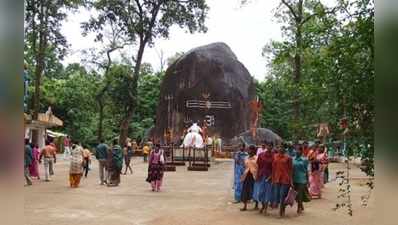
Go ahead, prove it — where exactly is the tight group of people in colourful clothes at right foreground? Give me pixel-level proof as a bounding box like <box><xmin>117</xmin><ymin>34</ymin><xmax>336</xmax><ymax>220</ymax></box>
<box><xmin>234</xmin><ymin>142</ymin><xmax>329</xmax><ymax>217</ymax></box>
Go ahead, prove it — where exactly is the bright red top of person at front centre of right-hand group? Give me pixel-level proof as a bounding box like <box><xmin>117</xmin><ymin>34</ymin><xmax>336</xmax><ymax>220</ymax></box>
<box><xmin>272</xmin><ymin>153</ymin><xmax>293</xmax><ymax>184</ymax></box>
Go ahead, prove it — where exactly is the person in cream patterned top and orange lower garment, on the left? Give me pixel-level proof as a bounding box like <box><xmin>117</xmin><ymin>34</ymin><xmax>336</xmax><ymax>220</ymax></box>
<box><xmin>69</xmin><ymin>144</ymin><xmax>83</xmax><ymax>188</ymax></box>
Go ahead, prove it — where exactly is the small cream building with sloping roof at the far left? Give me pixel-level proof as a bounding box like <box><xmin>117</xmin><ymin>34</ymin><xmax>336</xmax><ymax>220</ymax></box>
<box><xmin>24</xmin><ymin>108</ymin><xmax>63</xmax><ymax>148</ymax></box>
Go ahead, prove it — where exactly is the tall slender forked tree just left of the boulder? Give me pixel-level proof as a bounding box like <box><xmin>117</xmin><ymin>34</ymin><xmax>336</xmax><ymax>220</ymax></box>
<box><xmin>83</xmin><ymin>0</ymin><xmax>208</xmax><ymax>143</ymax></box>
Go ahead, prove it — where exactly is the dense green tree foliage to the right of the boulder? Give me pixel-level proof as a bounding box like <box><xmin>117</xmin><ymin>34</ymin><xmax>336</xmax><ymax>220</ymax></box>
<box><xmin>257</xmin><ymin>0</ymin><xmax>375</xmax><ymax>175</ymax></box>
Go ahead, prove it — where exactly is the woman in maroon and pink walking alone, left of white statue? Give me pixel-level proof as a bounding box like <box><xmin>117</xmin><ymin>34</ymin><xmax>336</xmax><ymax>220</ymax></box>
<box><xmin>146</xmin><ymin>144</ymin><xmax>165</xmax><ymax>192</ymax></box>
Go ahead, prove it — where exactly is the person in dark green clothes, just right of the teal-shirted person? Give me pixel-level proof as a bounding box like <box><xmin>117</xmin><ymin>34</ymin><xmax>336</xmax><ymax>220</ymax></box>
<box><xmin>108</xmin><ymin>139</ymin><xmax>123</xmax><ymax>187</ymax></box>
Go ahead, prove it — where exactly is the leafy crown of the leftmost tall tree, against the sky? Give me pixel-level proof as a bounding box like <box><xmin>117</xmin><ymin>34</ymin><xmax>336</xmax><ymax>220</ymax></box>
<box><xmin>25</xmin><ymin>0</ymin><xmax>83</xmax><ymax>74</ymax></box>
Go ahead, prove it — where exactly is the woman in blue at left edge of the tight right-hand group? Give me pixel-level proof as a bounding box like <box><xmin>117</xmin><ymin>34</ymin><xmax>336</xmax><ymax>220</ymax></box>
<box><xmin>234</xmin><ymin>143</ymin><xmax>249</xmax><ymax>203</ymax></box>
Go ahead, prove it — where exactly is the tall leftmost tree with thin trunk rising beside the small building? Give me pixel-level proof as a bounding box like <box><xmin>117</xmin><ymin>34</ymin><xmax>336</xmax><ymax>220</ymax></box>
<box><xmin>25</xmin><ymin>0</ymin><xmax>81</xmax><ymax>143</ymax></box>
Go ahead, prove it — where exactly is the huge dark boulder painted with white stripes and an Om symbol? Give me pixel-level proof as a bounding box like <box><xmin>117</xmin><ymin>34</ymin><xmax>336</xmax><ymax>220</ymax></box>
<box><xmin>153</xmin><ymin>43</ymin><xmax>256</xmax><ymax>141</ymax></box>
